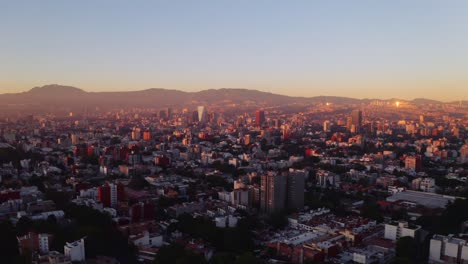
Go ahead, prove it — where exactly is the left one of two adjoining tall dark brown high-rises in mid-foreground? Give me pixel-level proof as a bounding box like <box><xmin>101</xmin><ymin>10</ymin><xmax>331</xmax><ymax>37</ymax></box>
<box><xmin>260</xmin><ymin>171</ymin><xmax>287</xmax><ymax>213</ymax></box>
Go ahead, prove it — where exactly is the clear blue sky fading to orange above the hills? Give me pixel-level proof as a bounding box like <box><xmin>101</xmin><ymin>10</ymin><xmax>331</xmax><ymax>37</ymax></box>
<box><xmin>0</xmin><ymin>0</ymin><xmax>468</xmax><ymax>100</ymax></box>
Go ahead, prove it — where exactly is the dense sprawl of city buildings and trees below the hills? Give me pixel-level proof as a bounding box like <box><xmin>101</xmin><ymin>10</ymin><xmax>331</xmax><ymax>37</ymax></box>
<box><xmin>0</xmin><ymin>86</ymin><xmax>468</xmax><ymax>264</ymax></box>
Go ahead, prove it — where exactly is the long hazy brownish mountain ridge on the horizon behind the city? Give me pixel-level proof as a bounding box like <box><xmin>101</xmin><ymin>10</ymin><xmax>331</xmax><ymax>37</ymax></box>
<box><xmin>0</xmin><ymin>84</ymin><xmax>450</xmax><ymax>112</ymax></box>
